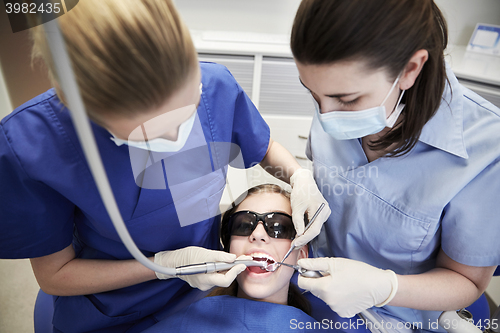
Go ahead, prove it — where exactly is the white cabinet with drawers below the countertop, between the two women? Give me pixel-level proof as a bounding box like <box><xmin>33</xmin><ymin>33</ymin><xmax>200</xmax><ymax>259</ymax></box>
<box><xmin>199</xmin><ymin>52</ymin><xmax>314</xmax><ymax>211</ymax></box>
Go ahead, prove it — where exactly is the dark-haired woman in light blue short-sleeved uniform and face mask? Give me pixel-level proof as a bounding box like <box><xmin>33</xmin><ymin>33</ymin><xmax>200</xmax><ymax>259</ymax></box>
<box><xmin>291</xmin><ymin>0</ymin><xmax>500</xmax><ymax>330</ymax></box>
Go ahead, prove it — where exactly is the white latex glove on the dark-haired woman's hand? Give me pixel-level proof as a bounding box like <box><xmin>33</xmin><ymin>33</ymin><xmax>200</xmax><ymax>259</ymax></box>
<box><xmin>298</xmin><ymin>258</ymin><xmax>398</xmax><ymax>318</ymax></box>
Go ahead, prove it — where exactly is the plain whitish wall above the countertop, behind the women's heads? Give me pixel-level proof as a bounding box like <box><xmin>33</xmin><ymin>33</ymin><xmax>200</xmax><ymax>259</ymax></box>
<box><xmin>174</xmin><ymin>0</ymin><xmax>500</xmax><ymax>45</ymax></box>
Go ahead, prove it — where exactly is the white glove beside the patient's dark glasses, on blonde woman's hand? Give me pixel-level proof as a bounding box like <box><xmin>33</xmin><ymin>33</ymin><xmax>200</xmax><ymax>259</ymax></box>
<box><xmin>290</xmin><ymin>169</ymin><xmax>331</xmax><ymax>247</ymax></box>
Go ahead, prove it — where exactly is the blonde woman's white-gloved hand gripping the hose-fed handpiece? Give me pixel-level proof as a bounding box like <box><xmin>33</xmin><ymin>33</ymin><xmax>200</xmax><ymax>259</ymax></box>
<box><xmin>154</xmin><ymin>246</ymin><xmax>246</xmax><ymax>291</ymax></box>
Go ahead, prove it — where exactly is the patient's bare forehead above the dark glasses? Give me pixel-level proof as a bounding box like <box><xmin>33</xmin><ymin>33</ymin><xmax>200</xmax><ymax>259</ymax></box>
<box><xmin>237</xmin><ymin>192</ymin><xmax>292</xmax><ymax>215</ymax></box>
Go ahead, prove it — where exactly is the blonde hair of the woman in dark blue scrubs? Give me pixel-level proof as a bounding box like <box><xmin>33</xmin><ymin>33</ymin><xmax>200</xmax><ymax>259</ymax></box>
<box><xmin>32</xmin><ymin>0</ymin><xmax>198</xmax><ymax>118</ymax></box>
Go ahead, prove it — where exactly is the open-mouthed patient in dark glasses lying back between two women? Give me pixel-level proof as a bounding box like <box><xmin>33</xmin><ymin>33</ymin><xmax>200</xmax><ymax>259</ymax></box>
<box><xmin>146</xmin><ymin>184</ymin><xmax>319</xmax><ymax>333</ymax></box>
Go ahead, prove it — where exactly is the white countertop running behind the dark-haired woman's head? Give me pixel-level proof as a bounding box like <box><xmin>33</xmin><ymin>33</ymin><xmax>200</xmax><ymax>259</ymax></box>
<box><xmin>191</xmin><ymin>30</ymin><xmax>500</xmax><ymax>87</ymax></box>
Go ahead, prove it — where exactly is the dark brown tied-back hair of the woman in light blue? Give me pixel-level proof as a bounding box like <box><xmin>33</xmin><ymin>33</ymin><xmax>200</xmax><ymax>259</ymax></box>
<box><xmin>291</xmin><ymin>0</ymin><xmax>448</xmax><ymax>156</ymax></box>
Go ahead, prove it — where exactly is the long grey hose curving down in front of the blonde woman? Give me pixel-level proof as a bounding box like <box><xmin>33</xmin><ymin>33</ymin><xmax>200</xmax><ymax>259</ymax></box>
<box><xmin>44</xmin><ymin>20</ymin><xmax>176</xmax><ymax>276</ymax></box>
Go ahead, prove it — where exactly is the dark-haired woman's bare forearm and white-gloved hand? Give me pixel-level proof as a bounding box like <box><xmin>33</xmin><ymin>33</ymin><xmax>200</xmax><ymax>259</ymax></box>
<box><xmin>298</xmin><ymin>250</ymin><xmax>496</xmax><ymax>317</ymax></box>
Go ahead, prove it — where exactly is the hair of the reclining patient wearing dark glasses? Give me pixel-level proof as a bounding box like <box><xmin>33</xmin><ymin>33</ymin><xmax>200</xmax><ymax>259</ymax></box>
<box><xmin>207</xmin><ymin>184</ymin><xmax>311</xmax><ymax>315</ymax></box>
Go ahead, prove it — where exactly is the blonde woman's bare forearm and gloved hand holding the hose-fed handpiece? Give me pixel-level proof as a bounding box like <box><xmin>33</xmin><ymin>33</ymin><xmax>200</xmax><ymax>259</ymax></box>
<box><xmin>30</xmin><ymin>245</ymin><xmax>246</xmax><ymax>296</ymax></box>
